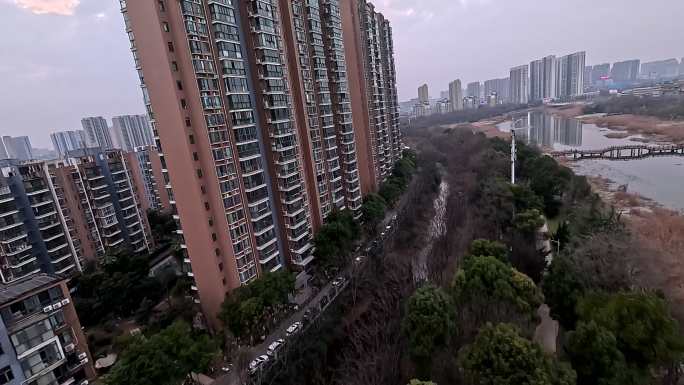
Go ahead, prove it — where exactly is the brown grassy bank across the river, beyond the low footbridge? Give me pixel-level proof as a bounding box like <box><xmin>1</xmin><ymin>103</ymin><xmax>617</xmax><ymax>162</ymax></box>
<box><xmin>542</xmin><ymin>105</ymin><xmax>684</xmax><ymax>144</ymax></box>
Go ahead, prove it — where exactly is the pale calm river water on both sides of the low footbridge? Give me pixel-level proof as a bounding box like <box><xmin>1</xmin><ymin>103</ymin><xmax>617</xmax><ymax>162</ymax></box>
<box><xmin>497</xmin><ymin>112</ymin><xmax>684</xmax><ymax>211</ymax></box>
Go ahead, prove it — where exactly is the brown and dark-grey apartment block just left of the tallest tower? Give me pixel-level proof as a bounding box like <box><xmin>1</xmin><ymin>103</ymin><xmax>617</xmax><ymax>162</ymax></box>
<box><xmin>47</xmin><ymin>148</ymin><xmax>152</xmax><ymax>261</ymax></box>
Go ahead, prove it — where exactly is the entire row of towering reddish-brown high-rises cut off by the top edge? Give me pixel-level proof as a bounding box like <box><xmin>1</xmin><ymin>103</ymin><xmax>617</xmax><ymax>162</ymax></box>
<box><xmin>121</xmin><ymin>0</ymin><xmax>401</xmax><ymax>325</ymax></box>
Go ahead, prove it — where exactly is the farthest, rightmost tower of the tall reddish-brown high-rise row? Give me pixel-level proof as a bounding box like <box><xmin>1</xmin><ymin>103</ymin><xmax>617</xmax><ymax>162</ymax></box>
<box><xmin>340</xmin><ymin>0</ymin><xmax>400</xmax><ymax>189</ymax></box>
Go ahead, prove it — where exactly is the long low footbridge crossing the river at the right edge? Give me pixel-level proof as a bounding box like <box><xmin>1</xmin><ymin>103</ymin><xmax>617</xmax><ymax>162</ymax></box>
<box><xmin>550</xmin><ymin>144</ymin><xmax>684</xmax><ymax>160</ymax></box>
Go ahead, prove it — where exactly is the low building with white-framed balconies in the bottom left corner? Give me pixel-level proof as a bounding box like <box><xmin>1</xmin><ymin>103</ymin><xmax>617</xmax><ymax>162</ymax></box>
<box><xmin>0</xmin><ymin>274</ymin><xmax>95</xmax><ymax>385</ymax></box>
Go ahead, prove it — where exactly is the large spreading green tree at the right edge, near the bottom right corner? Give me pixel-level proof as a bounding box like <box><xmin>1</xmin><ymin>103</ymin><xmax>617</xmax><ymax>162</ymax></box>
<box><xmin>578</xmin><ymin>292</ymin><xmax>684</xmax><ymax>369</ymax></box>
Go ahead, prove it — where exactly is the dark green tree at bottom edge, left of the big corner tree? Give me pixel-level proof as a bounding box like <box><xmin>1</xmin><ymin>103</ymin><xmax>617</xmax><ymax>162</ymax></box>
<box><xmin>565</xmin><ymin>321</ymin><xmax>632</xmax><ymax>385</ymax></box>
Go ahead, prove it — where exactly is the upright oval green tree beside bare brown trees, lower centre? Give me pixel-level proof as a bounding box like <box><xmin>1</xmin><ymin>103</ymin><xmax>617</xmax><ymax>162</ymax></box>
<box><xmin>402</xmin><ymin>286</ymin><xmax>454</xmax><ymax>359</ymax></box>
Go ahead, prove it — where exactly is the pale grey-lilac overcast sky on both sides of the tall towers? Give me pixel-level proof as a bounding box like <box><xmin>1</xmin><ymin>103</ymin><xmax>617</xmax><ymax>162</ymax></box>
<box><xmin>0</xmin><ymin>0</ymin><xmax>684</xmax><ymax>147</ymax></box>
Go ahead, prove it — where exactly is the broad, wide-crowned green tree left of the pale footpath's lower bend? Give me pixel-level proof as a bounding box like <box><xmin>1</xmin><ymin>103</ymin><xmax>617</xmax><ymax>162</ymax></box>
<box><xmin>451</xmin><ymin>256</ymin><xmax>542</xmax><ymax>327</ymax></box>
